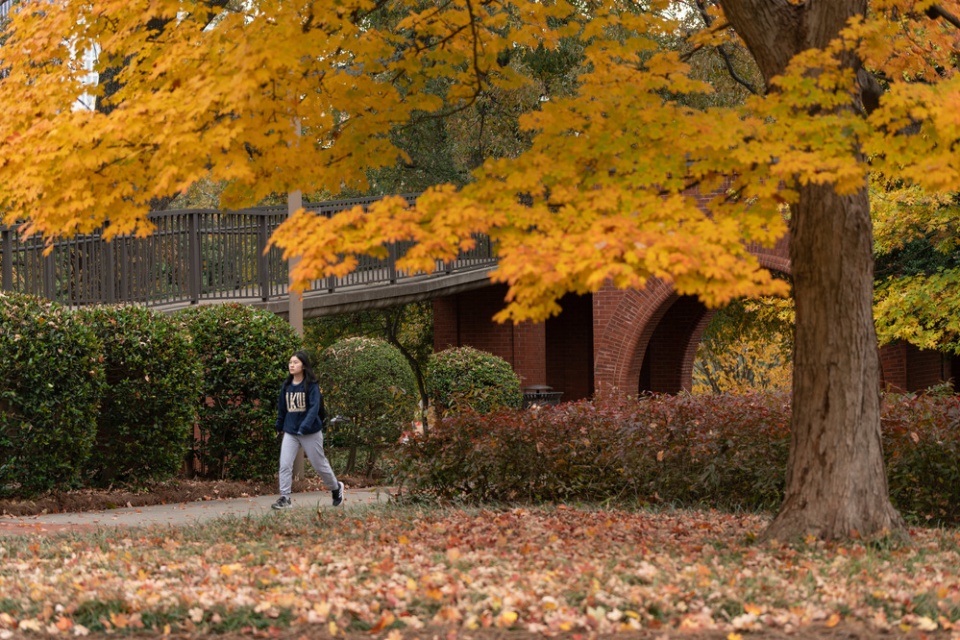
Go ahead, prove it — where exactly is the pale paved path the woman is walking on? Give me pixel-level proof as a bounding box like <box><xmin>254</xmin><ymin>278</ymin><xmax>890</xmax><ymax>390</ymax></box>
<box><xmin>0</xmin><ymin>487</ymin><xmax>391</xmax><ymax>536</ymax></box>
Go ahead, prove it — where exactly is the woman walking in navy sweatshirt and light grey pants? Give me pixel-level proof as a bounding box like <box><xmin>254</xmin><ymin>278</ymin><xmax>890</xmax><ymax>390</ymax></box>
<box><xmin>273</xmin><ymin>351</ymin><xmax>343</xmax><ymax>509</ymax></box>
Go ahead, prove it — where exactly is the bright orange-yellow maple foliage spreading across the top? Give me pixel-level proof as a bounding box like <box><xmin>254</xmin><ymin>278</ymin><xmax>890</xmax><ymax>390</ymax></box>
<box><xmin>0</xmin><ymin>0</ymin><xmax>960</xmax><ymax>320</ymax></box>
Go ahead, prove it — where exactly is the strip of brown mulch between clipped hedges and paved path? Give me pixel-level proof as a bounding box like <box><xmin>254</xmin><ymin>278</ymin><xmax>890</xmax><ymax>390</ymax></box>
<box><xmin>0</xmin><ymin>476</ymin><xmax>377</xmax><ymax>517</ymax></box>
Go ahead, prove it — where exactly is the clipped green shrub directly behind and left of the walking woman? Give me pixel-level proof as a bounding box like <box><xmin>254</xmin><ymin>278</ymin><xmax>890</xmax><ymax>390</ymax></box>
<box><xmin>177</xmin><ymin>304</ymin><xmax>300</xmax><ymax>480</ymax></box>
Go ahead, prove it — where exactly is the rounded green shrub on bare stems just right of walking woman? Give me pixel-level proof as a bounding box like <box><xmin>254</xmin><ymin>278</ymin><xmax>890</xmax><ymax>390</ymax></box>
<box><xmin>315</xmin><ymin>338</ymin><xmax>419</xmax><ymax>475</ymax></box>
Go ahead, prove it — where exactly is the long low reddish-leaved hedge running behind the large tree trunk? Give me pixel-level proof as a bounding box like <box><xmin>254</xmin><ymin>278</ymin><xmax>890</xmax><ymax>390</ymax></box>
<box><xmin>400</xmin><ymin>393</ymin><xmax>960</xmax><ymax>523</ymax></box>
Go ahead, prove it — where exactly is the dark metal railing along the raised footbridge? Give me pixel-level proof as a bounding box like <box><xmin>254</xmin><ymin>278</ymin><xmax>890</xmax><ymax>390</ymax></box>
<box><xmin>0</xmin><ymin>195</ymin><xmax>496</xmax><ymax>306</ymax></box>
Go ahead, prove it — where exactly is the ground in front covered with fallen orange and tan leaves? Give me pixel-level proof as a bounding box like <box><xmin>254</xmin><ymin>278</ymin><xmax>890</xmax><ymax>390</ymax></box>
<box><xmin>0</xmin><ymin>505</ymin><xmax>960</xmax><ymax>640</ymax></box>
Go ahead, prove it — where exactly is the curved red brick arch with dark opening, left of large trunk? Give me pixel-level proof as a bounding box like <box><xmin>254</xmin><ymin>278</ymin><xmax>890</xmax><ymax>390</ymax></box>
<box><xmin>593</xmin><ymin>237</ymin><xmax>791</xmax><ymax>394</ymax></box>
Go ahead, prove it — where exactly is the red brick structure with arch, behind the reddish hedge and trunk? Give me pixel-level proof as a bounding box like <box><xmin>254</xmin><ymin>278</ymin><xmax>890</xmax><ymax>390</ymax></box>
<box><xmin>433</xmin><ymin>230</ymin><xmax>960</xmax><ymax>400</ymax></box>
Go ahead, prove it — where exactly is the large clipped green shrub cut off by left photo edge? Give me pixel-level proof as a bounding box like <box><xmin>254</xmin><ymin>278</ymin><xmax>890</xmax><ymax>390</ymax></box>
<box><xmin>0</xmin><ymin>293</ymin><xmax>104</xmax><ymax>497</ymax></box>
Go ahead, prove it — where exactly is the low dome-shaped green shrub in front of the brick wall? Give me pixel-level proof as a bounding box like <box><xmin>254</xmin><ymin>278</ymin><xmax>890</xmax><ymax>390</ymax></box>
<box><xmin>426</xmin><ymin>347</ymin><xmax>523</xmax><ymax>416</ymax></box>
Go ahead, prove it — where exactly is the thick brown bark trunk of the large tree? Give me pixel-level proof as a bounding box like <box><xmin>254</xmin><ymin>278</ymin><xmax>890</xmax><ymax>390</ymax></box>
<box><xmin>720</xmin><ymin>0</ymin><xmax>904</xmax><ymax>540</ymax></box>
